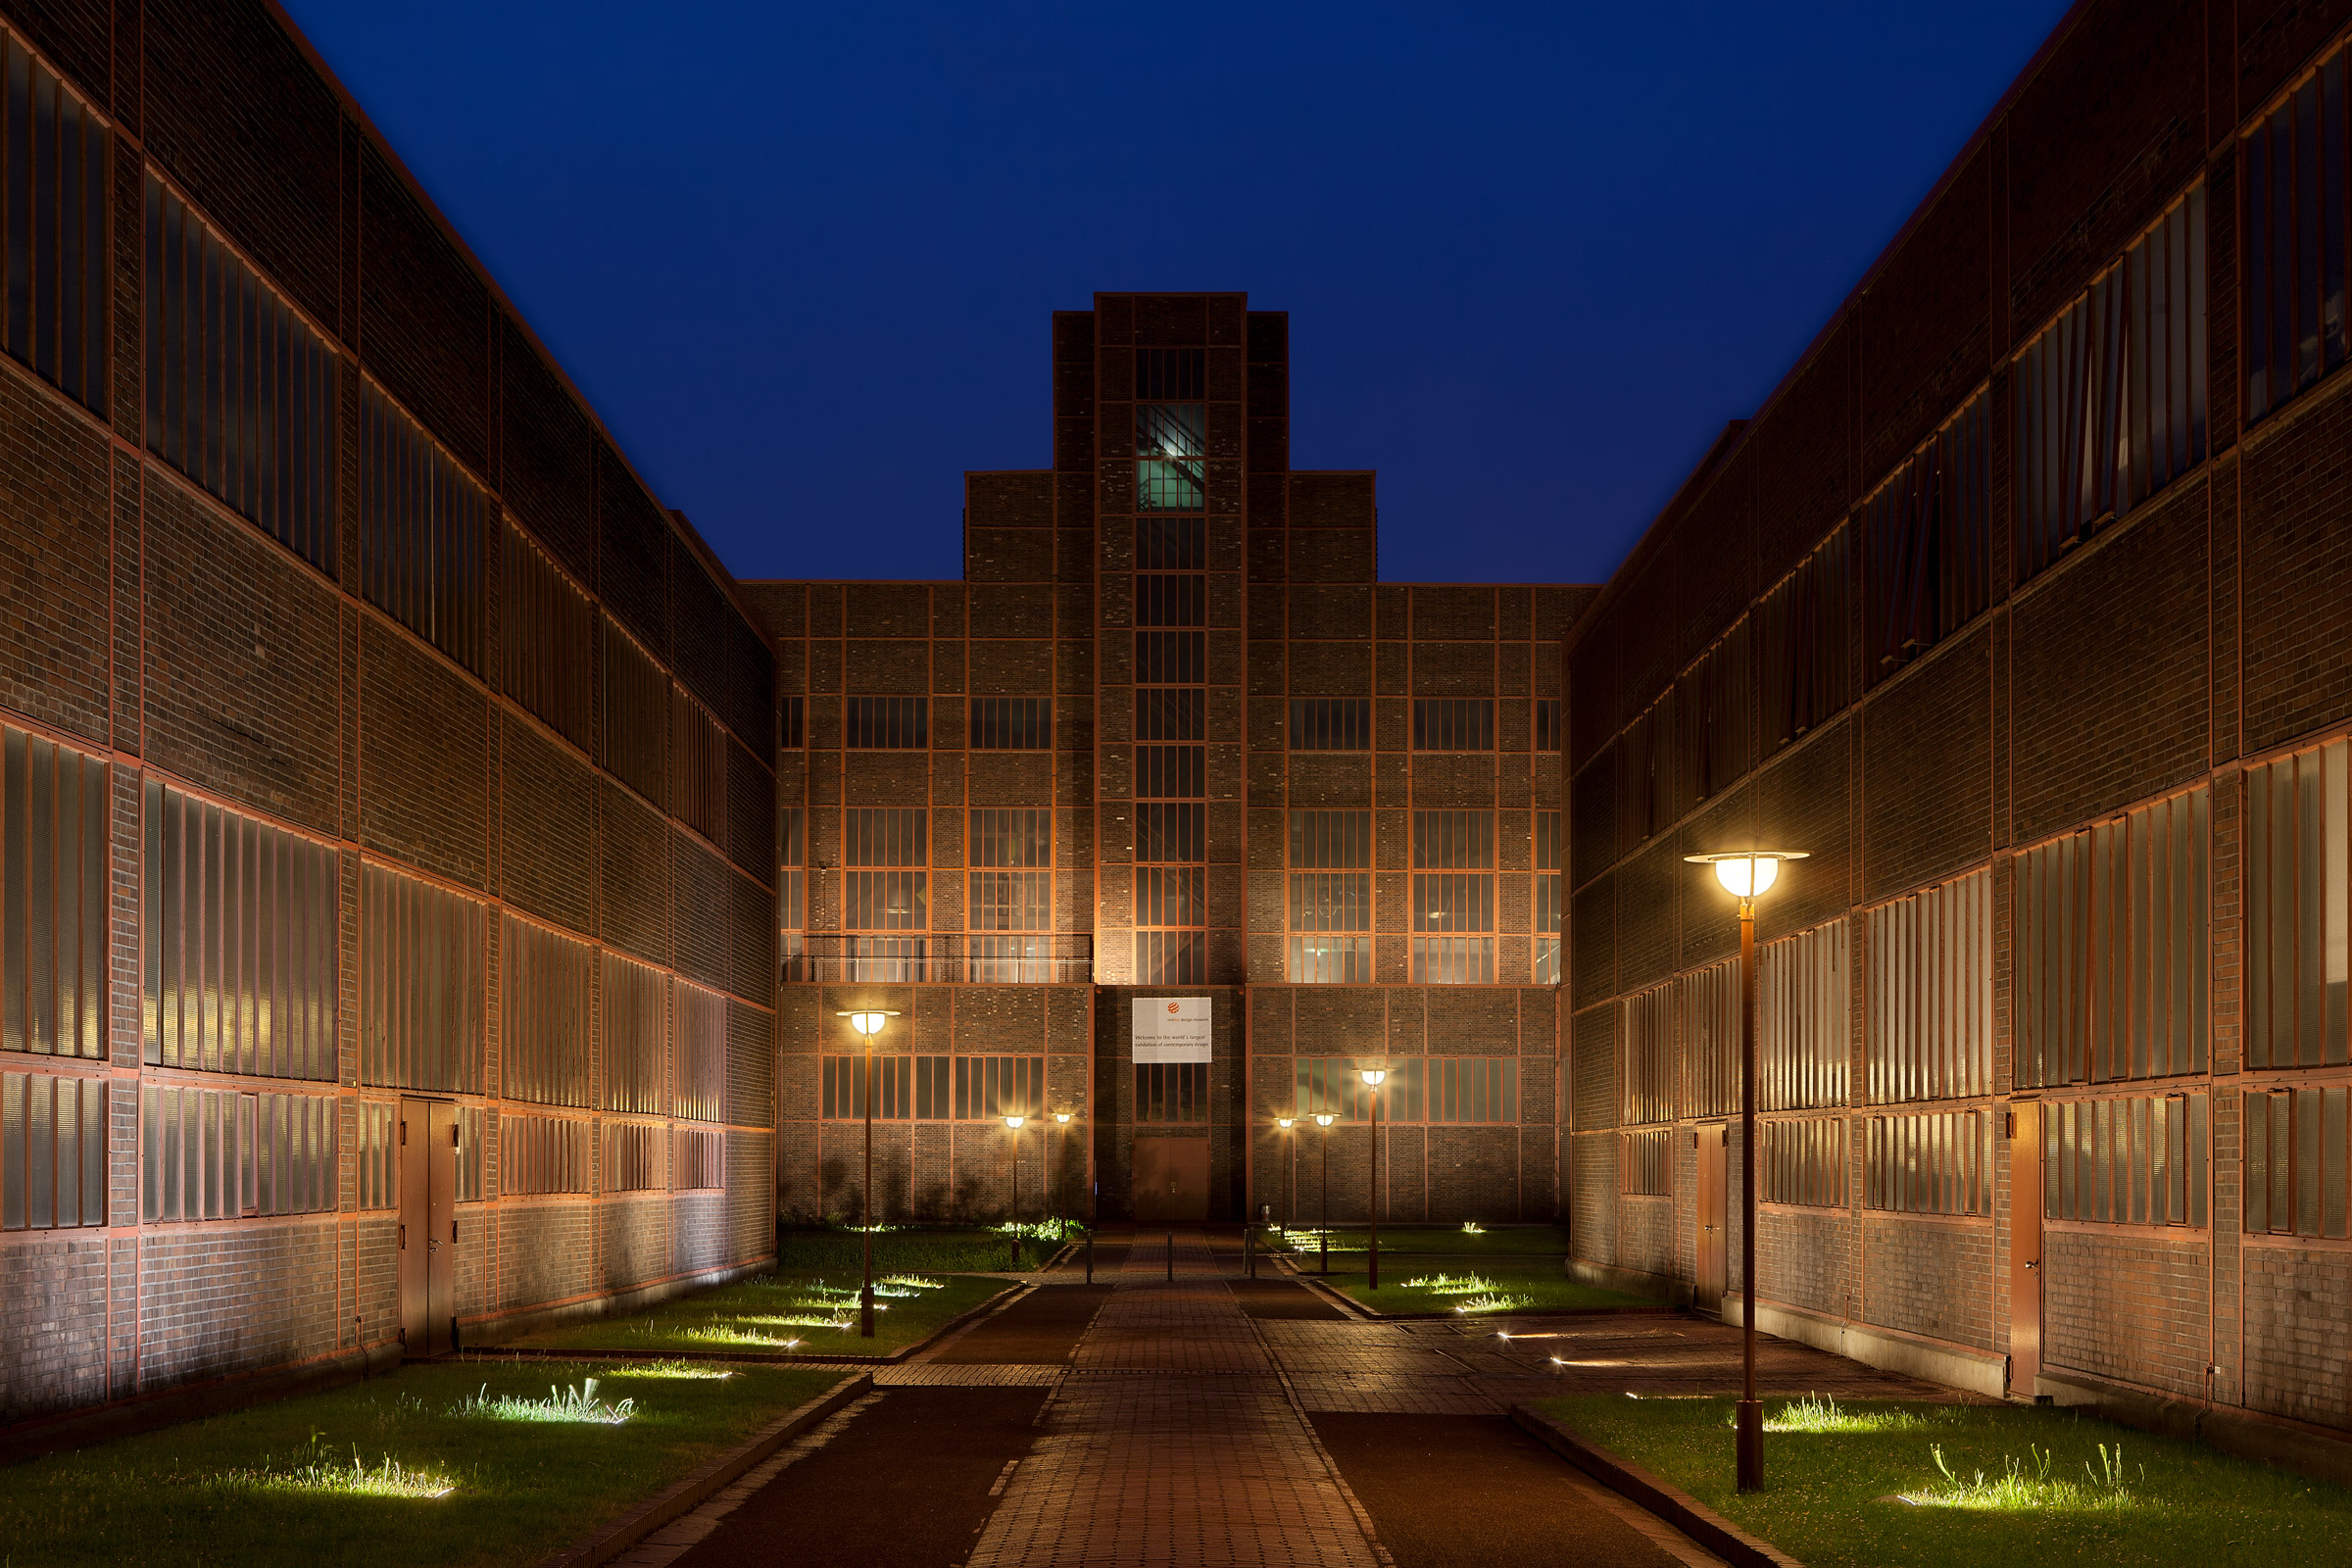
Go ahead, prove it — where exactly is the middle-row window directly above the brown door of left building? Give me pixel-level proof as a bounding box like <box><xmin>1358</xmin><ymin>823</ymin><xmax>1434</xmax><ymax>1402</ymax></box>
<box><xmin>360</xmin><ymin>865</ymin><xmax>484</xmax><ymax>1093</ymax></box>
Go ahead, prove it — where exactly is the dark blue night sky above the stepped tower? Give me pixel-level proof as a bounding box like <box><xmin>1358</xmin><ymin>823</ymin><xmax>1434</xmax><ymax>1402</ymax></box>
<box><xmin>287</xmin><ymin>0</ymin><xmax>2065</xmax><ymax>581</ymax></box>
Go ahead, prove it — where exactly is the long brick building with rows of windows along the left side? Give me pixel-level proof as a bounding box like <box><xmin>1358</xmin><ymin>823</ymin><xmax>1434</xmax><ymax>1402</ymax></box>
<box><xmin>0</xmin><ymin>0</ymin><xmax>776</xmax><ymax>1420</ymax></box>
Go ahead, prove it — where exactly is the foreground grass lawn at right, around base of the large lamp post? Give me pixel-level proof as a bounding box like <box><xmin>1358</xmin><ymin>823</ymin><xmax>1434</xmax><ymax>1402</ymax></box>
<box><xmin>1541</xmin><ymin>1396</ymin><xmax>2352</xmax><ymax>1568</ymax></box>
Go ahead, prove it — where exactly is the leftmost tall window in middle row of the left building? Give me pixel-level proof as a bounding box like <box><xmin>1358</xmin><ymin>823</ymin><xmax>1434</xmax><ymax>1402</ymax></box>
<box><xmin>0</xmin><ymin>733</ymin><xmax>103</xmax><ymax>1072</ymax></box>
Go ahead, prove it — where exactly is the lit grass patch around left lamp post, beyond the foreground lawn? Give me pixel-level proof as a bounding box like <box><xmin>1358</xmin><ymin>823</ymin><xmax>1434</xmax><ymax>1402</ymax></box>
<box><xmin>515</xmin><ymin>1257</ymin><xmax>1006</xmax><ymax>1356</ymax></box>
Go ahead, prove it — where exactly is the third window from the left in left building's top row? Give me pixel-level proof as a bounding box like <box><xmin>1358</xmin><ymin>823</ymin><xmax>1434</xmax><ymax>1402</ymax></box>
<box><xmin>360</xmin><ymin>378</ymin><xmax>489</xmax><ymax>674</ymax></box>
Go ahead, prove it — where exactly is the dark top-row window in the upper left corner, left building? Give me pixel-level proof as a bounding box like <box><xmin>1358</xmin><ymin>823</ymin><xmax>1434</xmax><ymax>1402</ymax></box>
<box><xmin>0</xmin><ymin>33</ymin><xmax>113</xmax><ymax>418</ymax></box>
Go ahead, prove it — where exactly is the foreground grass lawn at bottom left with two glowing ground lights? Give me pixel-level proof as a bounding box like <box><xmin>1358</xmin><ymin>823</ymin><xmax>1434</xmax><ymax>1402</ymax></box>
<box><xmin>0</xmin><ymin>1361</ymin><xmax>842</xmax><ymax>1568</ymax></box>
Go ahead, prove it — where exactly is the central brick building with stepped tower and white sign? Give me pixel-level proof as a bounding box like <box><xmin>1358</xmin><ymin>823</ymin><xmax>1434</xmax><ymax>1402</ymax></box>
<box><xmin>746</xmin><ymin>294</ymin><xmax>1592</xmax><ymax>1220</ymax></box>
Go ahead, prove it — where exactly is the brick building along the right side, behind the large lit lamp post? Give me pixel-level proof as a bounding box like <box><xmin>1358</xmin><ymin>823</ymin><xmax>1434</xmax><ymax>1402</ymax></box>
<box><xmin>1566</xmin><ymin>2</ymin><xmax>2352</xmax><ymax>1441</ymax></box>
